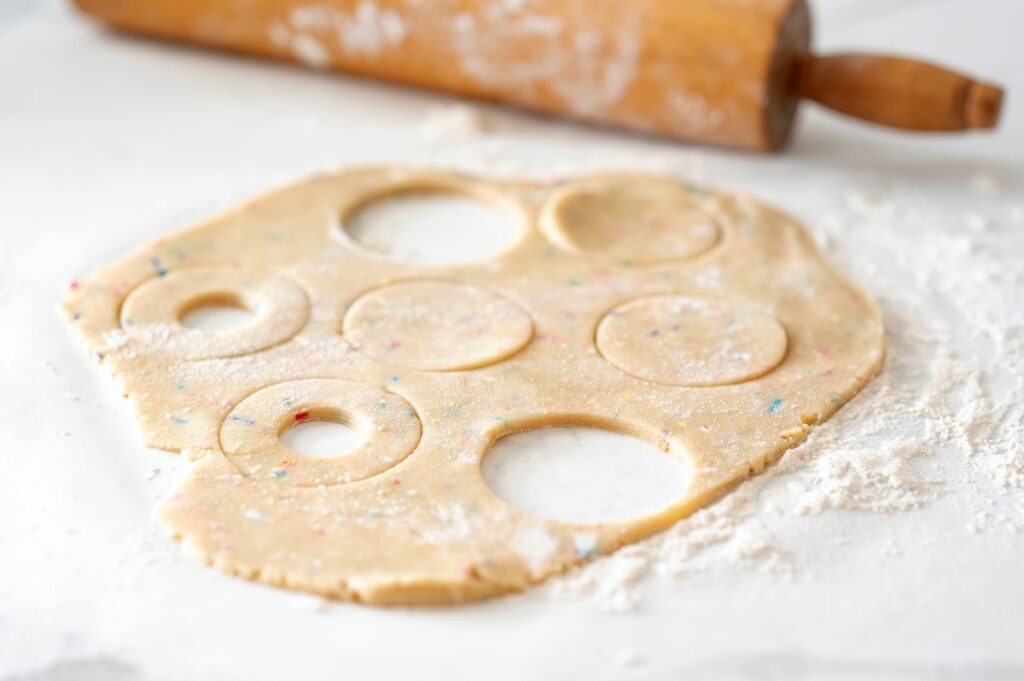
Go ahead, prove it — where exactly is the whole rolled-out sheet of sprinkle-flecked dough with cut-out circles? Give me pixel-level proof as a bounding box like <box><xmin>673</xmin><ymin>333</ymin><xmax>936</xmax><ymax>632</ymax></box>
<box><xmin>62</xmin><ymin>168</ymin><xmax>883</xmax><ymax>604</ymax></box>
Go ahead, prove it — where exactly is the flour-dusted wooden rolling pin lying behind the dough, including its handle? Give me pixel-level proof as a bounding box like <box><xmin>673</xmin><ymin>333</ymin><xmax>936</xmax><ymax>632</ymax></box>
<box><xmin>76</xmin><ymin>0</ymin><xmax>1002</xmax><ymax>151</ymax></box>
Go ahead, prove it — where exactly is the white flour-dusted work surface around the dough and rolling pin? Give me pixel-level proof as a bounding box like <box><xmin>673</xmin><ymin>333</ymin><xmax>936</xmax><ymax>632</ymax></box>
<box><xmin>0</xmin><ymin>0</ymin><xmax>1024</xmax><ymax>681</ymax></box>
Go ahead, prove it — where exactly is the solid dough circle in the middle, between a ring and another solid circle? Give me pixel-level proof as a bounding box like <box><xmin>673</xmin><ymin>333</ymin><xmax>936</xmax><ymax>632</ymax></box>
<box><xmin>342</xmin><ymin>281</ymin><xmax>534</xmax><ymax>371</ymax></box>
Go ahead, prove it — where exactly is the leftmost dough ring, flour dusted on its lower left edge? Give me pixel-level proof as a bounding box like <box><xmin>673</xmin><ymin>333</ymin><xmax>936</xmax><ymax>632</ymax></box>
<box><xmin>121</xmin><ymin>266</ymin><xmax>309</xmax><ymax>359</ymax></box>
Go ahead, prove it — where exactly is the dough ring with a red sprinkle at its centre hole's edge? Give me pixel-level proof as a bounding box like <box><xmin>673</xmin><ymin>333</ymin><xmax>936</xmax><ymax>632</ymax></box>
<box><xmin>220</xmin><ymin>379</ymin><xmax>422</xmax><ymax>486</ymax></box>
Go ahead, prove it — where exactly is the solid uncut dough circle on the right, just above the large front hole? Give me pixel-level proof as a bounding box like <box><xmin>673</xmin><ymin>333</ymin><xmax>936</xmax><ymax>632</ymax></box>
<box><xmin>596</xmin><ymin>295</ymin><xmax>786</xmax><ymax>387</ymax></box>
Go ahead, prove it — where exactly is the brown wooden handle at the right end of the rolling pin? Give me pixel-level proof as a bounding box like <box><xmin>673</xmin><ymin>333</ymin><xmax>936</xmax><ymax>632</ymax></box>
<box><xmin>797</xmin><ymin>53</ymin><xmax>1002</xmax><ymax>132</ymax></box>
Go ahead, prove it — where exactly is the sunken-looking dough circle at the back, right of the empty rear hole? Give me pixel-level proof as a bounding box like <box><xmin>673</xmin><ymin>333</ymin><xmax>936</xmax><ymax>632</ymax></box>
<box><xmin>541</xmin><ymin>176</ymin><xmax>719</xmax><ymax>264</ymax></box>
